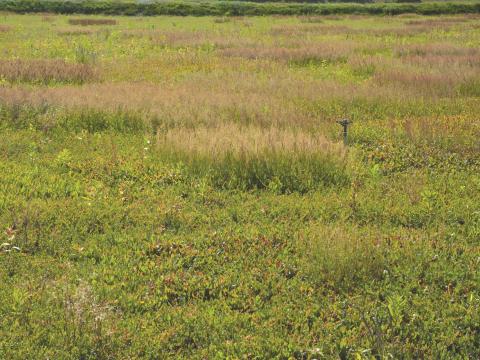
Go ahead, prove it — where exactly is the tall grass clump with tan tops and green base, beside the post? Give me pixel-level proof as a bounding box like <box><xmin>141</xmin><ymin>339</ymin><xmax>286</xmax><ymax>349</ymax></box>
<box><xmin>156</xmin><ymin>124</ymin><xmax>349</xmax><ymax>193</ymax></box>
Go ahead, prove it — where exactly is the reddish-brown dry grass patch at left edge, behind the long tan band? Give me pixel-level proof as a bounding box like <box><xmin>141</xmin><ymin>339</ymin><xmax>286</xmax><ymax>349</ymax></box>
<box><xmin>0</xmin><ymin>60</ymin><xmax>97</xmax><ymax>84</ymax></box>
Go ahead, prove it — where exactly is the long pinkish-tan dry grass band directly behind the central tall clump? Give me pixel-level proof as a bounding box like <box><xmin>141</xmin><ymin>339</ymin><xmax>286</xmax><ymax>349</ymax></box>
<box><xmin>0</xmin><ymin>73</ymin><xmax>436</xmax><ymax>129</ymax></box>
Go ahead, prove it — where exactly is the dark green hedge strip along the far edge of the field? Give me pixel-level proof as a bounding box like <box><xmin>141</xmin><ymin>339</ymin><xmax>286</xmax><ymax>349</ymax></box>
<box><xmin>0</xmin><ymin>0</ymin><xmax>480</xmax><ymax>16</ymax></box>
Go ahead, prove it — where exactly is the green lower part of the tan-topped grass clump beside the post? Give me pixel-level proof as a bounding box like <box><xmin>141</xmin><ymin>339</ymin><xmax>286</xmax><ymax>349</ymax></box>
<box><xmin>160</xmin><ymin>148</ymin><xmax>349</xmax><ymax>194</ymax></box>
